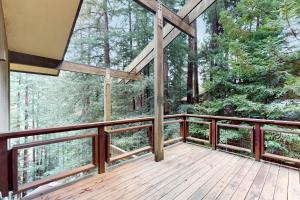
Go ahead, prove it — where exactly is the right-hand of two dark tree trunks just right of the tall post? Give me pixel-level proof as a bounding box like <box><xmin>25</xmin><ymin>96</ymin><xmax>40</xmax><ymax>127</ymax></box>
<box><xmin>192</xmin><ymin>20</ymin><xmax>199</xmax><ymax>103</ymax></box>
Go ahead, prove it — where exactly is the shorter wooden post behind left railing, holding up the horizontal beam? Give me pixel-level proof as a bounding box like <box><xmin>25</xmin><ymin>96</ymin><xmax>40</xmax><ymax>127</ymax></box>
<box><xmin>104</xmin><ymin>68</ymin><xmax>112</xmax><ymax>131</ymax></box>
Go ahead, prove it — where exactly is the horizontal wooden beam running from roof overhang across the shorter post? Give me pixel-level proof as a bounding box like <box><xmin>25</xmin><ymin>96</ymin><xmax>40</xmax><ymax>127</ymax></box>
<box><xmin>57</xmin><ymin>61</ymin><xmax>142</xmax><ymax>80</ymax></box>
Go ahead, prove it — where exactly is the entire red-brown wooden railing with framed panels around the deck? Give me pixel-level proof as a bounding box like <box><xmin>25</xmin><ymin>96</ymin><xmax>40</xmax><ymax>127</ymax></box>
<box><xmin>0</xmin><ymin>114</ymin><xmax>300</xmax><ymax>196</ymax></box>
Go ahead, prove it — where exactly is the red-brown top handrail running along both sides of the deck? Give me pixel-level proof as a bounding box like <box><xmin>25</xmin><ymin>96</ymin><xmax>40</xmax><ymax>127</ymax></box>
<box><xmin>0</xmin><ymin>114</ymin><xmax>300</xmax><ymax>139</ymax></box>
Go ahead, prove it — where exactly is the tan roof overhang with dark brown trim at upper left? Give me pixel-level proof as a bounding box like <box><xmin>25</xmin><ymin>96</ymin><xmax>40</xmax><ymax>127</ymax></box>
<box><xmin>2</xmin><ymin>0</ymin><xmax>83</xmax><ymax>75</ymax></box>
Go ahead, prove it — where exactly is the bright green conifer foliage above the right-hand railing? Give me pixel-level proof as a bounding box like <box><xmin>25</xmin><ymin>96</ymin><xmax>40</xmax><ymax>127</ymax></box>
<box><xmin>197</xmin><ymin>0</ymin><xmax>300</xmax><ymax>119</ymax></box>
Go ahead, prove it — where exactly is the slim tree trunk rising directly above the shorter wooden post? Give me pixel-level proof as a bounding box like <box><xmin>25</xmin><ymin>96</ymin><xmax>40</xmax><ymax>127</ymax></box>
<box><xmin>102</xmin><ymin>0</ymin><xmax>110</xmax><ymax>67</ymax></box>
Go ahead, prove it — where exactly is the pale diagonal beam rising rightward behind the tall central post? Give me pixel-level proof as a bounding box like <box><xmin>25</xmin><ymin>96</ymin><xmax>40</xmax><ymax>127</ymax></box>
<box><xmin>126</xmin><ymin>0</ymin><xmax>216</xmax><ymax>77</ymax></box>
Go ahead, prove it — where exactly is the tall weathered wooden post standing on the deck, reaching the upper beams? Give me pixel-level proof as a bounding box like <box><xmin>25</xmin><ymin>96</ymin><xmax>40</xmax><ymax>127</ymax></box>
<box><xmin>154</xmin><ymin>3</ymin><xmax>164</xmax><ymax>162</ymax></box>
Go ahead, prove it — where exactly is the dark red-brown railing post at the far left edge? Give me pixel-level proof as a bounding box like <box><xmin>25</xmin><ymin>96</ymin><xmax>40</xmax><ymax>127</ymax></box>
<box><xmin>0</xmin><ymin>138</ymin><xmax>10</xmax><ymax>197</ymax></box>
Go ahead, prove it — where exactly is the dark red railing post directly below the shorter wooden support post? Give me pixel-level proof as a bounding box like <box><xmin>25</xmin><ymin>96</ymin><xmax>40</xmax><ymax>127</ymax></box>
<box><xmin>98</xmin><ymin>126</ymin><xmax>107</xmax><ymax>174</ymax></box>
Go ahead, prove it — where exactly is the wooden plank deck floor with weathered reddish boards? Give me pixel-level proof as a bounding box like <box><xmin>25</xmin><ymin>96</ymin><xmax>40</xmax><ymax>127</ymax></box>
<box><xmin>31</xmin><ymin>143</ymin><xmax>300</xmax><ymax>200</ymax></box>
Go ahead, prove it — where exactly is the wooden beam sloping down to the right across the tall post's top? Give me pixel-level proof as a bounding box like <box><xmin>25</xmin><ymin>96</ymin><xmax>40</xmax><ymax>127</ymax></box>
<box><xmin>134</xmin><ymin>0</ymin><xmax>196</xmax><ymax>37</ymax></box>
